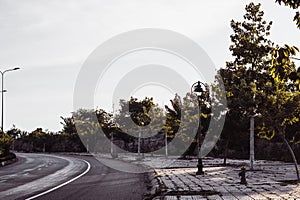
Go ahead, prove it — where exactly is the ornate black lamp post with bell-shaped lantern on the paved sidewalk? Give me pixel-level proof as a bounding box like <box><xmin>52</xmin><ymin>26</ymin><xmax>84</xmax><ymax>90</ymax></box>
<box><xmin>191</xmin><ymin>81</ymin><xmax>205</xmax><ymax>175</ymax></box>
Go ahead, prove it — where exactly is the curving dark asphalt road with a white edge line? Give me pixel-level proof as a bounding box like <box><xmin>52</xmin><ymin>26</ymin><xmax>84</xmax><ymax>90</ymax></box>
<box><xmin>0</xmin><ymin>154</ymin><xmax>146</xmax><ymax>200</ymax></box>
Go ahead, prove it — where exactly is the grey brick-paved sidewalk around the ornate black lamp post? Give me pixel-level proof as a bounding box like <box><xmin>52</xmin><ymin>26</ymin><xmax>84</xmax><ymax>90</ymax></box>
<box><xmin>154</xmin><ymin>159</ymin><xmax>300</xmax><ymax>200</ymax></box>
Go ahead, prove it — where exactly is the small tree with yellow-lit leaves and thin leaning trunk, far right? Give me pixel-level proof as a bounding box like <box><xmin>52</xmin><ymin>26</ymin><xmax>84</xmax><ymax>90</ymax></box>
<box><xmin>259</xmin><ymin>45</ymin><xmax>300</xmax><ymax>180</ymax></box>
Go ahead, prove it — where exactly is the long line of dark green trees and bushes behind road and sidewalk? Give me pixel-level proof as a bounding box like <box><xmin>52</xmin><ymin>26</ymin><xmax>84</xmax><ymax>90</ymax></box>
<box><xmin>0</xmin><ymin>0</ymin><xmax>300</xmax><ymax>177</ymax></box>
